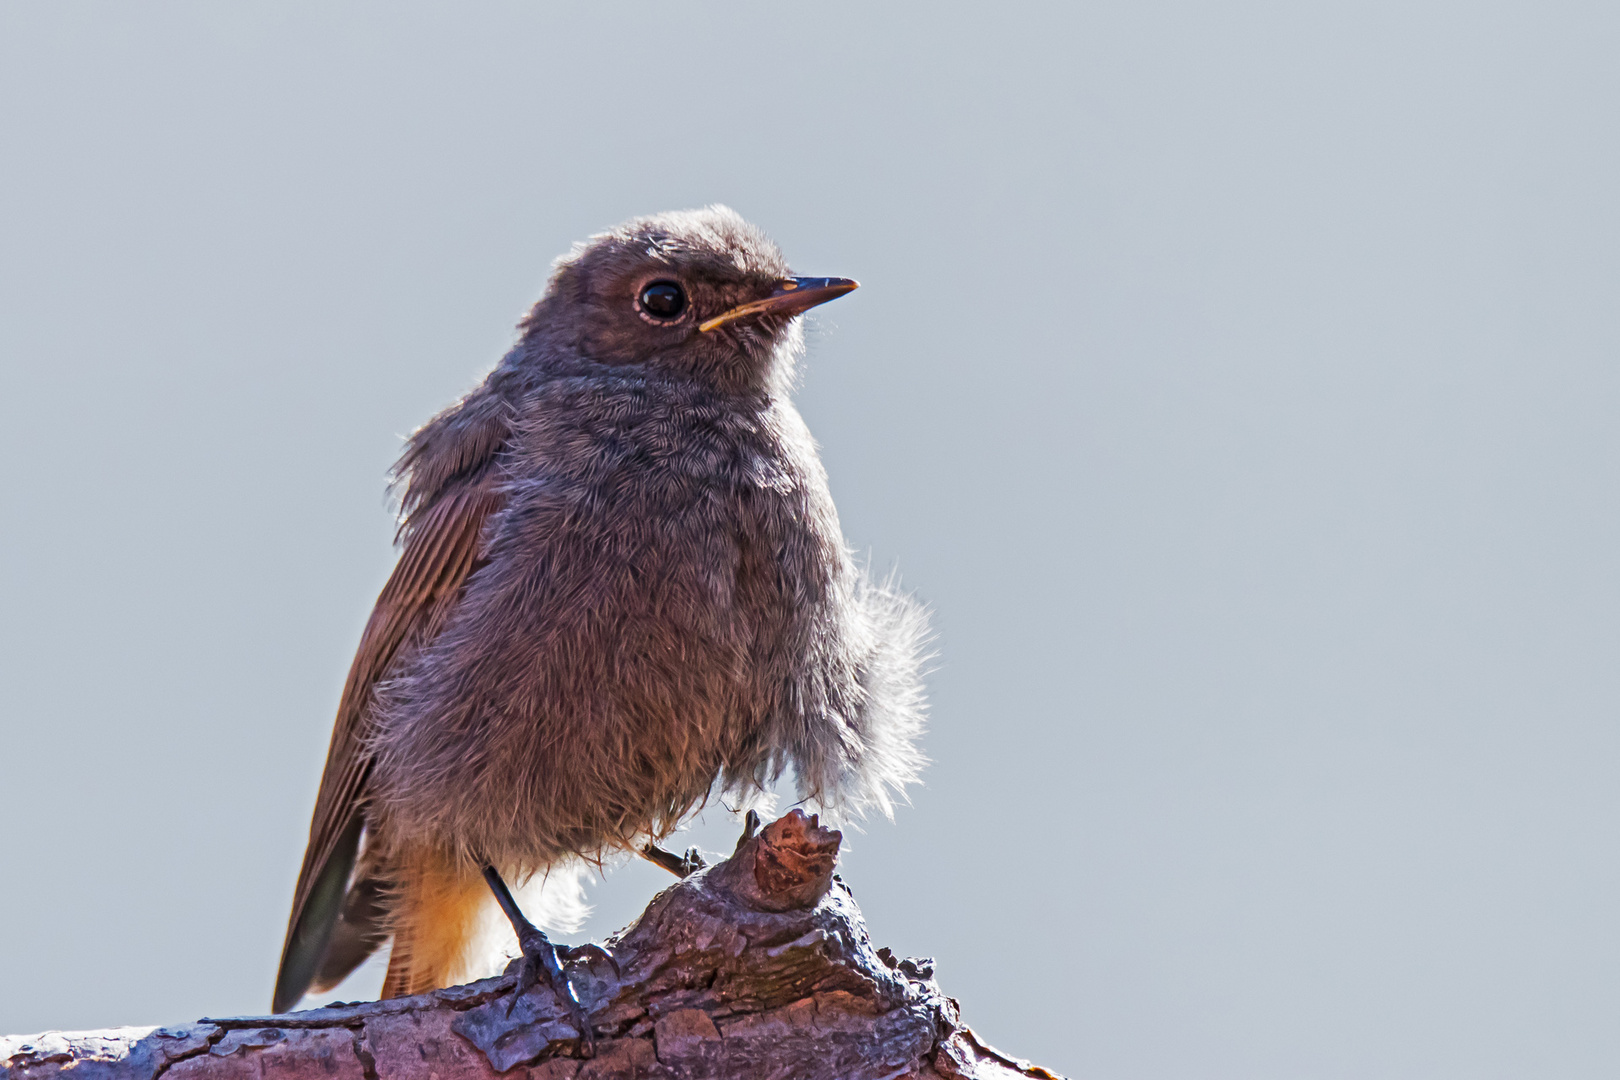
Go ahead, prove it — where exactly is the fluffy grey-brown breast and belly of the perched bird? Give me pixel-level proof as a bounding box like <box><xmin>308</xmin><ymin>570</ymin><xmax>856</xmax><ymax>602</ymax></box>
<box><xmin>377</xmin><ymin>383</ymin><xmax>842</xmax><ymax>865</ymax></box>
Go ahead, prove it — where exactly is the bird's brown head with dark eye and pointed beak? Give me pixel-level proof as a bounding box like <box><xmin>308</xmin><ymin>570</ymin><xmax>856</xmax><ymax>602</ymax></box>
<box><xmin>522</xmin><ymin>206</ymin><xmax>855</xmax><ymax>390</ymax></box>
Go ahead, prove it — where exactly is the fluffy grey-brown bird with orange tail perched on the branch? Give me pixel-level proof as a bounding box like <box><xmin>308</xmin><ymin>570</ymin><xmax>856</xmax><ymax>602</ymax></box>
<box><xmin>272</xmin><ymin>204</ymin><xmax>928</xmax><ymax>1038</ymax></box>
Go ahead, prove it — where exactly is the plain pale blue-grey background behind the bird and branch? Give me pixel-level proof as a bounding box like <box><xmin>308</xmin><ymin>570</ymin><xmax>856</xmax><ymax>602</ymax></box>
<box><xmin>0</xmin><ymin>0</ymin><xmax>1620</xmax><ymax>1078</ymax></box>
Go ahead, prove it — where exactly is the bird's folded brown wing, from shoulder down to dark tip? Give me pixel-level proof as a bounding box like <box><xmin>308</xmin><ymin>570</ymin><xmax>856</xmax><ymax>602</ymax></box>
<box><xmin>272</xmin><ymin>468</ymin><xmax>501</xmax><ymax>1012</ymax></box>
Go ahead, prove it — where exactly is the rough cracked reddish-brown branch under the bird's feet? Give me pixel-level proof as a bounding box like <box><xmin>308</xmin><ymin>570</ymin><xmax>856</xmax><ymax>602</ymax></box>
<box><xmin>0</xmin><ymin>810</ymin><xmax>1053</xmax><ymax>1080</ymax></box>
